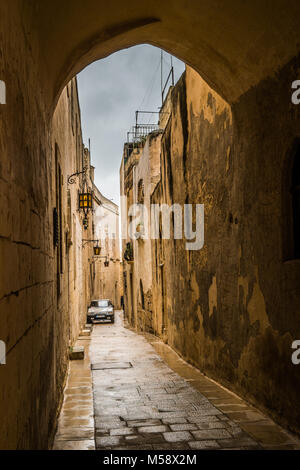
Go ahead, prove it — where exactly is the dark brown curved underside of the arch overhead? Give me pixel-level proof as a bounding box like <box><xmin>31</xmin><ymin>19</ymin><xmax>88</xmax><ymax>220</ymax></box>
<box><xmin>27</xmin><ymin>0</ymin><xmax>300</xmax><ymax>107</ymax></box>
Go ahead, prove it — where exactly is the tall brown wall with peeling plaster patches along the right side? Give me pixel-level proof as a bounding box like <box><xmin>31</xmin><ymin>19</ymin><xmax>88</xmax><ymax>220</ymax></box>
<box><xmin>152</xmin><ymin>65</ymin><xmax>300</xmax><ymax>431</ymax></box>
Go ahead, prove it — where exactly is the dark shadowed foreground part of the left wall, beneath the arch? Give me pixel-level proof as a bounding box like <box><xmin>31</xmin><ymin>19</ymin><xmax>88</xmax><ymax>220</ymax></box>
<box><xmin>0</xmin><ymin>2</ymin><xmax>61</xmax><ymax>449</ymax></box>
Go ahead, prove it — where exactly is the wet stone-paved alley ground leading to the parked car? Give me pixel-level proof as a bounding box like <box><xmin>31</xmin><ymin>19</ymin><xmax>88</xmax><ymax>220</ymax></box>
<box><xmin>54</xmin><ymin>312</ymin><xmax>300</xmax><ymax>450</ymax></box>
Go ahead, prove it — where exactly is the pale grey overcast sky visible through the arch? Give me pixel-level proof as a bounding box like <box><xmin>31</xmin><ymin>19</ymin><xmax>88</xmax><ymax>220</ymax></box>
<box><xmin>77</xmin><ymin>45</ymin><xmax>184</xmax><ymax>204</ymax></box>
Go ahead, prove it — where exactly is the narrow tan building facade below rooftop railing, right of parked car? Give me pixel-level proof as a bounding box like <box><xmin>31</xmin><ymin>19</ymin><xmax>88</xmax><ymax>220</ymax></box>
<box><xmin>120</xmin><ymin>126</ymin><xmax>162</xmax><ymax>331</ymax></box>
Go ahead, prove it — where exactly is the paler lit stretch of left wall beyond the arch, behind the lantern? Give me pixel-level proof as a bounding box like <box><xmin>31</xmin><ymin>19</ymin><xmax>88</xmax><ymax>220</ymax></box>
<box><xmin>51</xmin><ymin>80</ymin><xmax>94</xmax><ymax>348</ymax></box>
